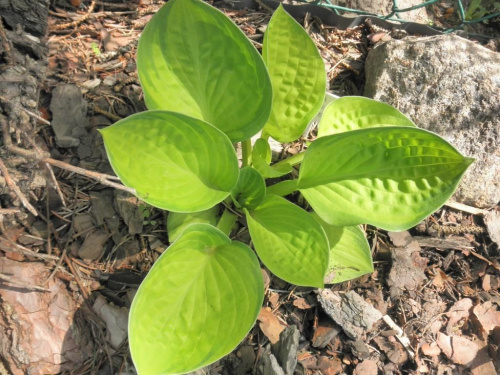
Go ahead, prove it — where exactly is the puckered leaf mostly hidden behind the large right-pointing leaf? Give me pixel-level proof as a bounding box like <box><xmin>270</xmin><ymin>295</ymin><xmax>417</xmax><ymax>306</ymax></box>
<box><xmin>318</xmin><ymin>96</ymin><xmax>415</xmax><ymax>137</ymax></box>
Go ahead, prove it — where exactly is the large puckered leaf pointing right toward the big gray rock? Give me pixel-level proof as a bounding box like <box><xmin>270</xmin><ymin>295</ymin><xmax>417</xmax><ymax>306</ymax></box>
<box><xmin>298</xmin><ymin>127</ymin><xmax>473</xmax><ymax>231</ymax></box>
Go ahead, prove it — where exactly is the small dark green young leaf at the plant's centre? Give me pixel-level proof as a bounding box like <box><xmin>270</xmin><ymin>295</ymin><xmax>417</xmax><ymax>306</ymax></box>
<box><xmin>231</xmin><ymin>167</ymin><xmax>266</xmax><ymax>210</ymax></box>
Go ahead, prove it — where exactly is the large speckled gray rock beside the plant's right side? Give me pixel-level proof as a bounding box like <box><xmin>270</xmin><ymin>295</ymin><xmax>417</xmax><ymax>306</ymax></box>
<box><xmin>364</xmin><ymin>35</ymin><xmax>500</xmax><ymax>208</ymax></box>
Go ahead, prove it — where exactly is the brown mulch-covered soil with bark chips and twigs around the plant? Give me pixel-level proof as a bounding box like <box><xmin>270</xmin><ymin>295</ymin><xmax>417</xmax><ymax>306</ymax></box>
<box><xmin>0</xmin><ymin>0</ymin><xmax>500</xmax><ymax>375</ymax></box>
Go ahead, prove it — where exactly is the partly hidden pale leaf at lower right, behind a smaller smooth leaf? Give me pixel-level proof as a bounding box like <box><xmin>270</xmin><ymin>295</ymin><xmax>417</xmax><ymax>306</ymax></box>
<box><xmin>312</xmin><ymin>213</ymin><xmax>373</xmax><ymax>284</ymax></box>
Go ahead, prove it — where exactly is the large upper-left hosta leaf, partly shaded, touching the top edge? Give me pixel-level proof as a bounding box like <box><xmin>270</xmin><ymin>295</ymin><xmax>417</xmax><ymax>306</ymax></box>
<box><xmin>137</xmin><ymin>0</ymin><xmax>272</xmax><ymax>143</ymax></box>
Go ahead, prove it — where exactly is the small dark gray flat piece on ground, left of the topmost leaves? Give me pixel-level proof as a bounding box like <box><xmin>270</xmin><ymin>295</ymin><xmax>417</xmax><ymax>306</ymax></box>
<box><xmin>50</xmin><ymin>84</ymin><xmax>88</xmax><ymax>147</ymax></box>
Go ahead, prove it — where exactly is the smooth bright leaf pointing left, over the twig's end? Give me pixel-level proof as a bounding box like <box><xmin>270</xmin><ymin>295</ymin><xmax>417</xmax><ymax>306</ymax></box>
<box><xmin>101</xmin><ymin>111</ymin><xmax>239</xmax><ymax>212</ymax></box>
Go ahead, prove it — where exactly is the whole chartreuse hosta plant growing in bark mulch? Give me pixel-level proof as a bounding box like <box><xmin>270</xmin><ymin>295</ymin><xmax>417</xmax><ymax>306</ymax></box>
<box><xmin>98</xmin><ymin>0</ymin><xmax>472</xmax><ymax>375</ymax></box>
